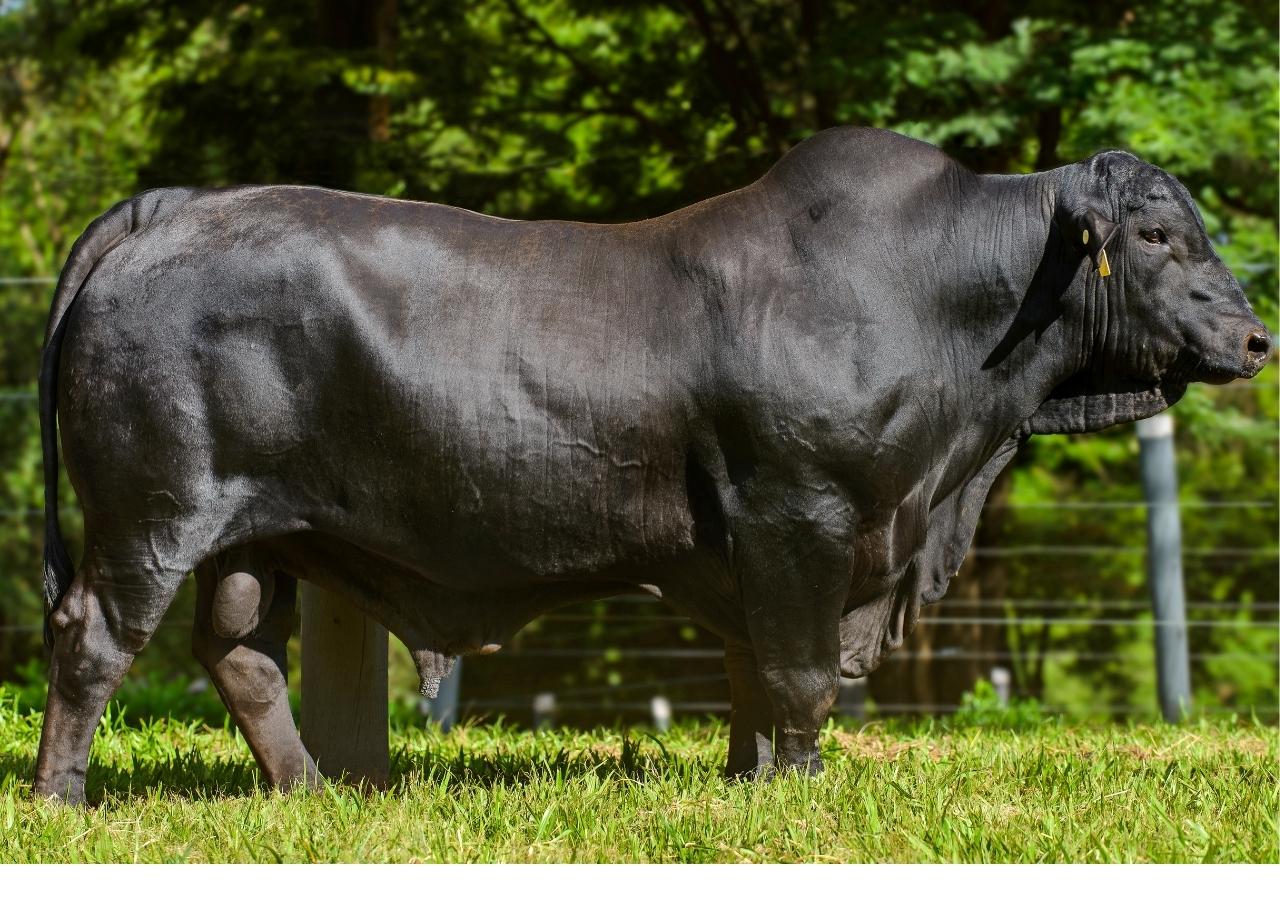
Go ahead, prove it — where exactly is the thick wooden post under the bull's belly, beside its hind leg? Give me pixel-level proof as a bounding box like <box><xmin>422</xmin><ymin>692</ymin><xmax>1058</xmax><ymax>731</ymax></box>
<box><xmin>302</xmin><ymin>585</ymin><xmax>390</xmax><ymax>787</ymax></box>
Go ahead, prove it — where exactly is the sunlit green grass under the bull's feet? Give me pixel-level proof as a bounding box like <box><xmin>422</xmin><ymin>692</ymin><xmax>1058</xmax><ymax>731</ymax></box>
<box><xmin>0</xmin><ymin>699</ymin><xmax>1280</xmax><ymax>863</ymax></box>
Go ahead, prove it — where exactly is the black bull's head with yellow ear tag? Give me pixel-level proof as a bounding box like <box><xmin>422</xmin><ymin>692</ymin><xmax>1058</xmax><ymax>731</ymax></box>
<box><xmin>1056</xmin><ymin>151</ymin><xmax>1272</xmax><ymax>389</ymax></box>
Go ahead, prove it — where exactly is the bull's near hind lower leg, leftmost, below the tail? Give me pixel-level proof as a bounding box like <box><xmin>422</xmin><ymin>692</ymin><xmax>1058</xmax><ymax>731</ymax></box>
<box><xmin>33</xmin><ymin>559</ymin><xmax>186</xmax><ymax>804</ymax></box>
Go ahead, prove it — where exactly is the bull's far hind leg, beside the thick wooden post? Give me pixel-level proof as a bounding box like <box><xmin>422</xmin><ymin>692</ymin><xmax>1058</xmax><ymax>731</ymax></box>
<box><xmin>192</xmin><ymin>554</ymin><xmax>320</xmax><ymax>790</ymax></box>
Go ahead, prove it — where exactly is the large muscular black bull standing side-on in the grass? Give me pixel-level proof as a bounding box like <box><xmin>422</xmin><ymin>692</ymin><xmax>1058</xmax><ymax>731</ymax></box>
<box><xmin>35</xmin><ymin>129</ymin><xmax>1270</xmax><ymax>801</ymax></box>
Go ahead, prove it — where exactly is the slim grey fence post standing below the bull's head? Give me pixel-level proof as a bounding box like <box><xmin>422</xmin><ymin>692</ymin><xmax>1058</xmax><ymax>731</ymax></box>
<box><xmin>1138</xmin><ymin>412</ymin><xmax>1192</xmax><ymax>722</ymax></box>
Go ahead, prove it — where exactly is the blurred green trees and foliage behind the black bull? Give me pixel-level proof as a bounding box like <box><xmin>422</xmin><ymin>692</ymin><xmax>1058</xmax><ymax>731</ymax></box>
<box><xmin>0</xmin><ymin>0</ymin><xmax>1280</xmax><ymax>719</ymax></box>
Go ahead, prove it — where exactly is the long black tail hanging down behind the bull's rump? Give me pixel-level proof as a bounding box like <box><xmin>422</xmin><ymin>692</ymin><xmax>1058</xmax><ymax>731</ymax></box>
<box><xmin>38</xmin><ymin>189</ymin><xmax>191</xmax><ymax>647</ymax></box>
